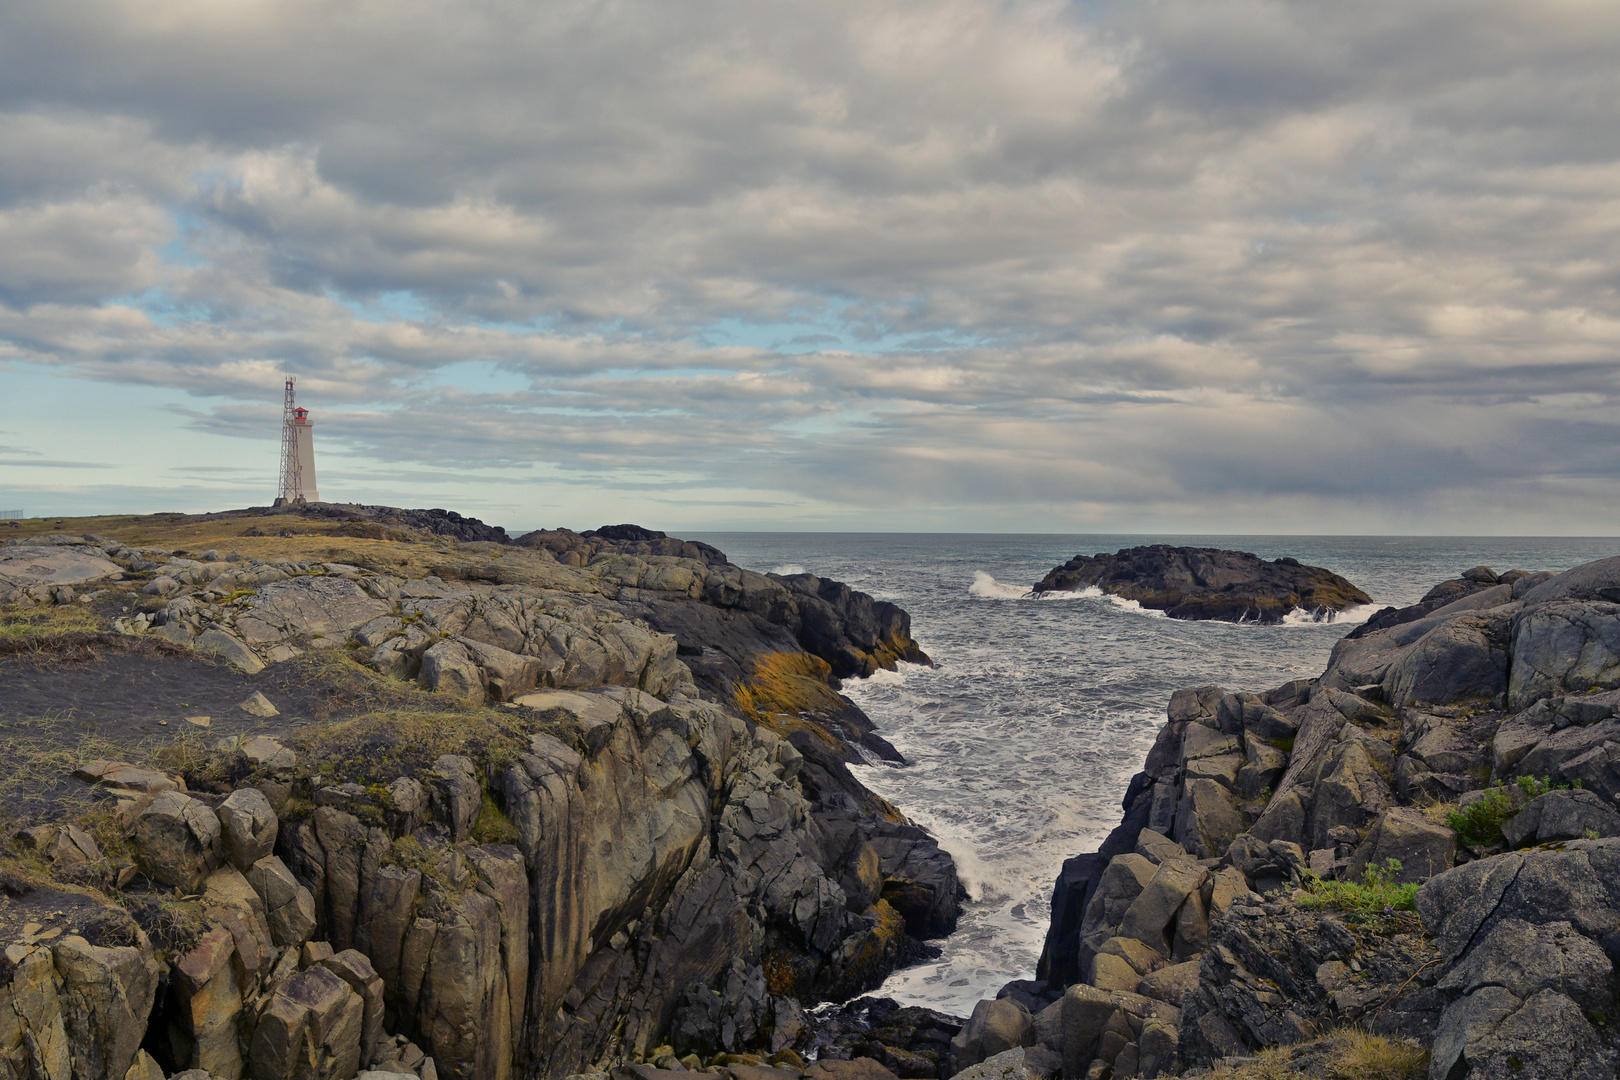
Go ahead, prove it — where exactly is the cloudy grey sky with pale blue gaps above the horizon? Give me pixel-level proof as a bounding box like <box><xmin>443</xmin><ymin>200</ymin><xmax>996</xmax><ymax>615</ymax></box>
<box><xmin>0</xmin><ymin>0</ymin><xmax>1620</xmax><ymax>534</ymax></box>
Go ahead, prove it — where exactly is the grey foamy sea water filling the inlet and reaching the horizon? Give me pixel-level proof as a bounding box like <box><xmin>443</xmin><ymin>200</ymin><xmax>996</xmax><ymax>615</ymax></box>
<box><xmin>690</xmin><ymin>533</ymin><xmax>1620</xmax><ymax>1015</ymax></box>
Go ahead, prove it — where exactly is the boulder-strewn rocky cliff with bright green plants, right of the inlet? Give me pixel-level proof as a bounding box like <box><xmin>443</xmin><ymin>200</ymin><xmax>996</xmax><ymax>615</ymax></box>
<box><xmin>951</xmin><ymin>559</ymin><xmax>1620</xmax><ymax>1080</ymax></box>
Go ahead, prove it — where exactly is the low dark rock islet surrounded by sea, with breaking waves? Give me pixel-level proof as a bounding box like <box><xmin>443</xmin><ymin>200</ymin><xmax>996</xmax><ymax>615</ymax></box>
<box><xmin>1034</xmin><ymin>544</ymin><xmax>1372</xmax><ymax>622</ymax></box>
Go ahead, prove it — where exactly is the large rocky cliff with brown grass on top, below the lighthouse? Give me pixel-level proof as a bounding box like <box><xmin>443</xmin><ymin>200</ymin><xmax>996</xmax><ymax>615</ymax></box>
<box><xmin>0</xmin><ymin>508</ymin><xmax>961</xmax><ymax>1080</ymax></box>
